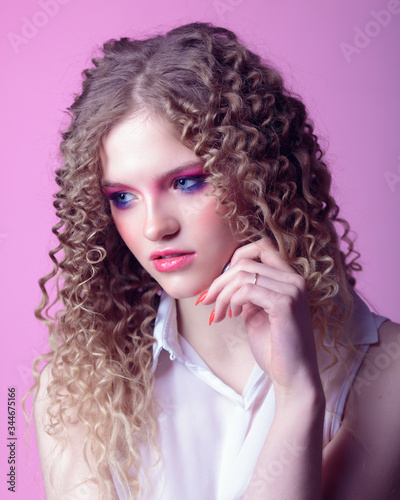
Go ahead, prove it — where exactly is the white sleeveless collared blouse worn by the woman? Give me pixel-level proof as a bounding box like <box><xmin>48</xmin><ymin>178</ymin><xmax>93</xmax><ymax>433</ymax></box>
<box><xmin>114</xmin><ymin>293</ymin><xmax>387</xmax><ymax>500</ymax></box>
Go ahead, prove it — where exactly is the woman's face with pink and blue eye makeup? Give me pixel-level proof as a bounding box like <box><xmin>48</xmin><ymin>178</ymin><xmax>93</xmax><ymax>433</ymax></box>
<box><xmin>101</xmin><ymin>114</ymin><xmax>239</xmax><ymax>298</ymax></box>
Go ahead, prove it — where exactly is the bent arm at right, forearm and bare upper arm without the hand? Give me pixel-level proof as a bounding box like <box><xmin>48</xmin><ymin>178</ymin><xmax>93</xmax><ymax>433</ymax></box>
<box><xmin>245</xmin><ymin>322</ymin><xmax>400</xmax><ymax>500</ymax></box>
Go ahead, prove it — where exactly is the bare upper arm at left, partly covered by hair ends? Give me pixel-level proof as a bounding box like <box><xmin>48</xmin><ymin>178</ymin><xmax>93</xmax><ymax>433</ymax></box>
<box><xmin>34</xmin><ymin>364</ymin><xmax>118</xmax><ymax>500</ymax></box>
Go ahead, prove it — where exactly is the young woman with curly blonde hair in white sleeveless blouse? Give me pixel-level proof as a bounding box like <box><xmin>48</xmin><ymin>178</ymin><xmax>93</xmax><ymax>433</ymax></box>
<box><xmin>35</xmin><ymin>23</ymin><xmax>400</xmax><ymax>500</ymax></box>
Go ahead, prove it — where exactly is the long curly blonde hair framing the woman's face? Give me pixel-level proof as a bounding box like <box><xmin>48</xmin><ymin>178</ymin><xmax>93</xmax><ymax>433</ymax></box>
<box><xmin>28</xmin><ymin>23</ymin><xmax>361</xmax><ymax>498</ymax></box>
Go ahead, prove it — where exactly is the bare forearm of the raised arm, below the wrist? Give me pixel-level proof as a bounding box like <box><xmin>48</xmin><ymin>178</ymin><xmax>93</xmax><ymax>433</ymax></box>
<box><xmin>245</xmin><ymin>380</ymin><xmax>325</xmax><ymax>500</ymax></box>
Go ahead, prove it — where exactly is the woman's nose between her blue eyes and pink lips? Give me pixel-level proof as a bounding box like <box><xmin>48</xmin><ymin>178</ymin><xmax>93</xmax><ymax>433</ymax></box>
<box><xmin>143</xmin><ymin>199</ymin><xmax>180</xmax><ymax>241</ymax></box>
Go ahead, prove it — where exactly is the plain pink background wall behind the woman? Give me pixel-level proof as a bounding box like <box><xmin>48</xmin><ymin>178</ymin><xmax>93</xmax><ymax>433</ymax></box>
<box><xmin>0</xmin><ymin>0</ymin><xmax>400</xmax><ymax>500</ymax></box>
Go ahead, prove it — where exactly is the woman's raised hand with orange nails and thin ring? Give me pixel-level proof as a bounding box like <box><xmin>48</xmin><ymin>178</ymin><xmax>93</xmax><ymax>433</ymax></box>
<box><xmin>202</xmin><ymin>238</ymin><xmax>321</xmax><ymax>394</ymax></box>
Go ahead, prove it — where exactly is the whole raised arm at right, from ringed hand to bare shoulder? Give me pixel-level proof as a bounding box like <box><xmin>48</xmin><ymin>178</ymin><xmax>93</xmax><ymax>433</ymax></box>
<box><xmin>202</xmin><ymin>239</ymin><xmax>400</xmax><ymax>500</ymax></box>
